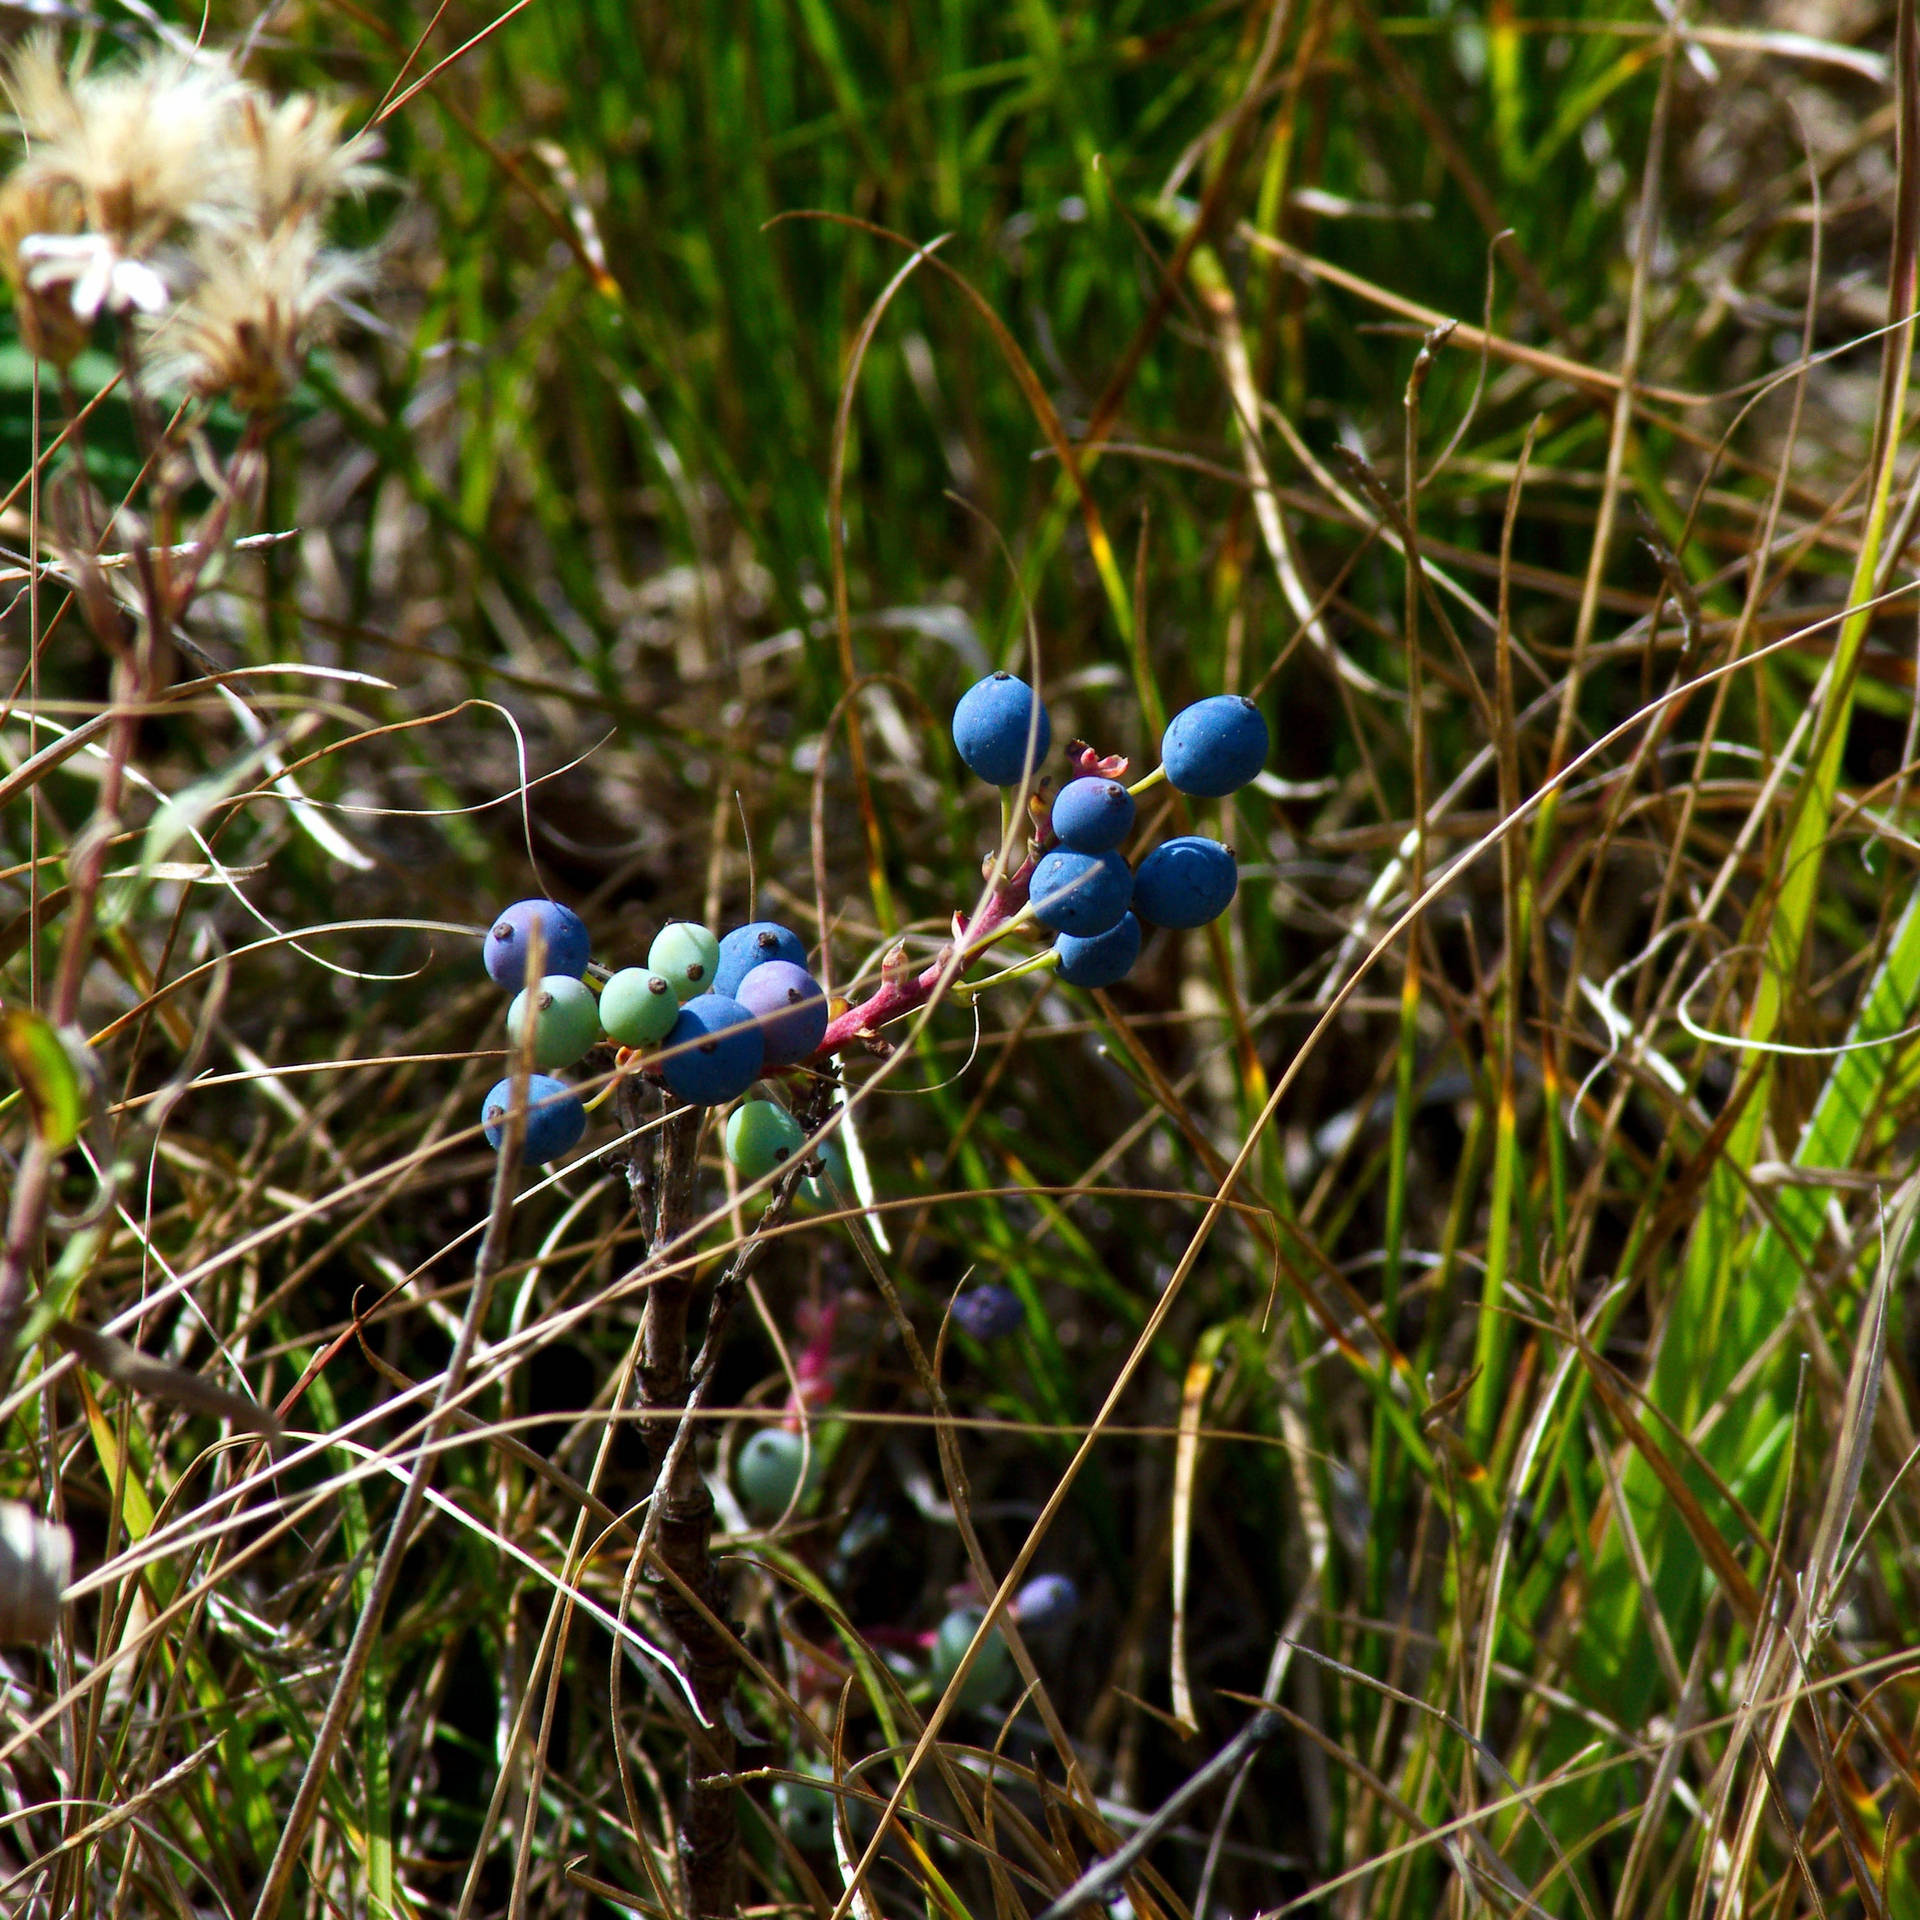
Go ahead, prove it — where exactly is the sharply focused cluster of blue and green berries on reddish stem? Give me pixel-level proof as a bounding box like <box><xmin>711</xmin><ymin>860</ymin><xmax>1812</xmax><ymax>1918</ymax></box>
<box><xmin>482</xmin><ymin>674</ymin><xmax>1269</xmax><ymax>1167</ymax></box>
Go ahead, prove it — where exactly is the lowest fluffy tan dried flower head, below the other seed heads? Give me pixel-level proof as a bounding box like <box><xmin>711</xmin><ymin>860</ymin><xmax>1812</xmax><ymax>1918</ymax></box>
<box><xmin>148</xmin><ymin>221</ymin><xmax>369</xmax><ymax>415</ymax></box>
